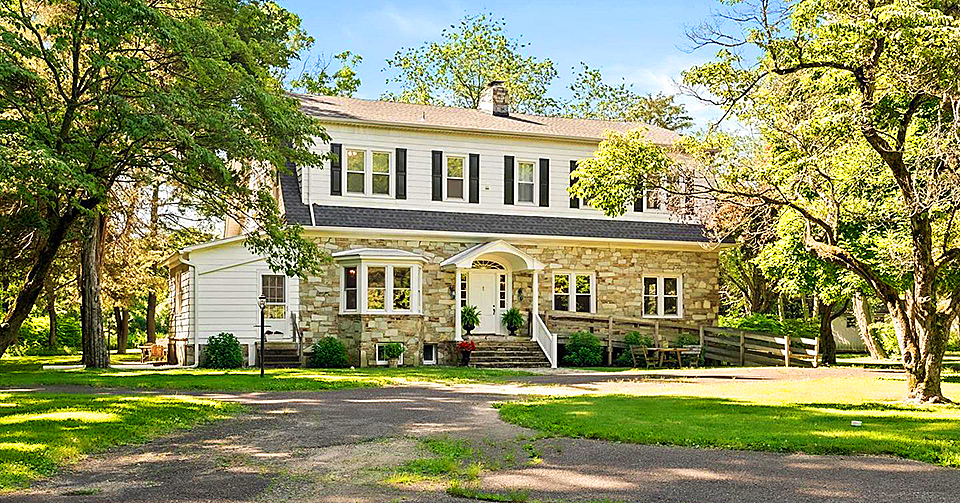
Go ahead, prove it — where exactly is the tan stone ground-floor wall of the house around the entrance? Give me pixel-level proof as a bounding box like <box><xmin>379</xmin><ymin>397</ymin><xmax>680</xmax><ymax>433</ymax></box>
<box><xmin>300</xmin><ymin>237</ymin><xmax>719</xmax><ymax>366</ymax></box>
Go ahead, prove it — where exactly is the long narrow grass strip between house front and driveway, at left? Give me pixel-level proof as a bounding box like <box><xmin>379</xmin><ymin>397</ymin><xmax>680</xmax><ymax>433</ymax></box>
<box><xmin>0</xmin><ymin>356</ymin><xmax>530</xmax><ymax>391</ymax></box>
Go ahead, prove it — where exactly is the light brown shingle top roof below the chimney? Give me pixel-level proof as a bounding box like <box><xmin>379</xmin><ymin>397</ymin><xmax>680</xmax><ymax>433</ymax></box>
<box><xmin>291</xmin><ymin>93</ymin><xmax>680</xmax><ymax>145</ymax></box>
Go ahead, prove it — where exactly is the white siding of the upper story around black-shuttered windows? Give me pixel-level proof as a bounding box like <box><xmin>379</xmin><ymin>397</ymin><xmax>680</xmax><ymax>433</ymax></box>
<box><xmin>300</xmin><ymin>124</ymin><xmax>670</xmax><ymax>221</ymax></box>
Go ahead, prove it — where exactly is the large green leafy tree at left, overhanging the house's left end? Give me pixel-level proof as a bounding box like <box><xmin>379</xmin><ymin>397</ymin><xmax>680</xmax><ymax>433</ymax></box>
<box><xmin>0</xmin><ymin>0</ymin><xmax>328</xmax><ymax>365</ymax></box>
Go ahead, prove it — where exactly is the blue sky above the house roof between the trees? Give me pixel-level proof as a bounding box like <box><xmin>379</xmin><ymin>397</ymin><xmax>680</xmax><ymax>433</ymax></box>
<box><xmin>279</xmin><ymin>0</ymin><xmax>718</xmax><ymax>126</ymax></box>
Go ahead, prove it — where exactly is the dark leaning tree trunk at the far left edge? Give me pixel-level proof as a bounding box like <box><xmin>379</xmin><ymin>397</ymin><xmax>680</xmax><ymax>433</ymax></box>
<box><xmin>0</xmin><ymin>208</ymin><xmax>80</xmax><ymax>356</ymax></box>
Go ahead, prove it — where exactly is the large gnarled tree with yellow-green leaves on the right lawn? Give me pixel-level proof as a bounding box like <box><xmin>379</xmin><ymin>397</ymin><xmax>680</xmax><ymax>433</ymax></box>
<box><xmin>579</xmin><ymin>0</ymin><xmax>960</xmax><ymax>402</ymax></box>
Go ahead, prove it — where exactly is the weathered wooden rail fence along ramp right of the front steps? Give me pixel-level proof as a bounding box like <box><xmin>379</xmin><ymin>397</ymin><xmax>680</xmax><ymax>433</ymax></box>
<box><xmin>543</xmin><ymin>311</ymin><xmax>820</xmax><ymax>367</ymax></box>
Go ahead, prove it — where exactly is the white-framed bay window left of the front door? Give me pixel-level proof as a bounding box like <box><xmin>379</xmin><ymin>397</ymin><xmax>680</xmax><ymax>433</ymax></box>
<box><xmin>340</xmin><ymin>262</ymin><xmax>421</xmax><ymax>314</ymax></box>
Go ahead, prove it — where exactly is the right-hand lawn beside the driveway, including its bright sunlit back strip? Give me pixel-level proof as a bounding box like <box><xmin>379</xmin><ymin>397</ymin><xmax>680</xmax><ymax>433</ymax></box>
<box><xmin>499</xmin><ymin>377</ymin><xmax>960</xmax><ymax>467</ymax></box>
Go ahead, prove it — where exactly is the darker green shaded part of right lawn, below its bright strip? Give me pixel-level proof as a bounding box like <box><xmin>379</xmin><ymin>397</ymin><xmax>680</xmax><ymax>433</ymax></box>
<box><xmin>499</xmin><ymin>395</ymin><xmax>960</xmax><ymax>467</ymax></box>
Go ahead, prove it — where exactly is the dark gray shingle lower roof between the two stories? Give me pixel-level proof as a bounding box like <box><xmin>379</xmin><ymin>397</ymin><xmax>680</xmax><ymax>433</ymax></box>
<box><xmin>313</xmin><ymin>204</ymin><xmax>709</xmax><ymax>243</ymax></box>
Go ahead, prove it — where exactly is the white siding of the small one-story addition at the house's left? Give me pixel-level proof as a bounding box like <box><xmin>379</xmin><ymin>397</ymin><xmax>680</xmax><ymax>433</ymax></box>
<box><xmin>189</xmin><ymin>242</ymin><xmax>300</xmax><ymax>344</ymax></box>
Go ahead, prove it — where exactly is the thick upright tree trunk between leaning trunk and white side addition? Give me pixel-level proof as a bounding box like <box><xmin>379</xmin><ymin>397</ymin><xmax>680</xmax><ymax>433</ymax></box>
<box><xmin>80</xmin><ymin>215</ymin><xmax>110</xmax><ymax>368</ymax></box>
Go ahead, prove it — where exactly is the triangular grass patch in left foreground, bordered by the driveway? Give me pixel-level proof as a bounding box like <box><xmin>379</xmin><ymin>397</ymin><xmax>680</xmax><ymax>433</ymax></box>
<box><xmin>0</xmin><ymin>393</ymin><xmax>241</xmax><ymax>491</ymax></box>
